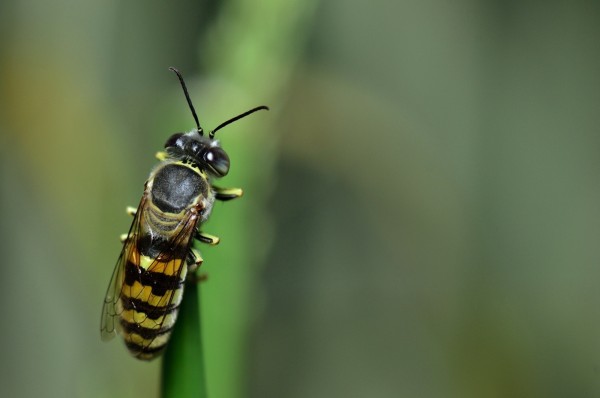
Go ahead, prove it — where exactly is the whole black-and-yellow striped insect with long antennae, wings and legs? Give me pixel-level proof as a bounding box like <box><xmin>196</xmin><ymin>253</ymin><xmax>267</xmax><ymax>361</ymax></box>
<box><xmin>100</xmin><ymin>67</ymin><xmax>269</xmax><ymax>360</ymax></box>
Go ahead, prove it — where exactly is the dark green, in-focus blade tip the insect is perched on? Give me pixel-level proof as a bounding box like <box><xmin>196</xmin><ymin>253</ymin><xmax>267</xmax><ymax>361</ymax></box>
<box><xmin>161</xmin><ymin>283</ymin><xmax>207</xmax><ymax>398</ymax></box>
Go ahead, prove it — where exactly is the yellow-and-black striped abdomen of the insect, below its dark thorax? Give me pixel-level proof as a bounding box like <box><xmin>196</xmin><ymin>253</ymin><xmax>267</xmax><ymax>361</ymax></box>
<box><xmin>118</xmin><ymin>203</ymin><xmax>197</xmax><ymax>359</ymax></box>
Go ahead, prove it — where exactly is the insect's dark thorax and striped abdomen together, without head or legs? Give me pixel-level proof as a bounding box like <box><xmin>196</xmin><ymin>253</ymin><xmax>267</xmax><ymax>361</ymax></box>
<box><xmin>118</xmin><ymin>164</ymin><xmax>210</xmax><ymax>359</ymax></box>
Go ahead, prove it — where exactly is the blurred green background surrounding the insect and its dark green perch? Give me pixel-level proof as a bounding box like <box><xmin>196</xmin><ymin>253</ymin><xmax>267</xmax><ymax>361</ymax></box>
<box><xmin>0</xmin><ymin>0</ymin><xmax>600</xmax><ymax>398</ymax></box>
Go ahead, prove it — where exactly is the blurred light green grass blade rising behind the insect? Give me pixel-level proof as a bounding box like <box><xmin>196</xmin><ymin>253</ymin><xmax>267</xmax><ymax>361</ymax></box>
<box><xmin>198</xmin><ymin>0</ymin><xmax>319</xmax><ymax>398</ymax></box>
